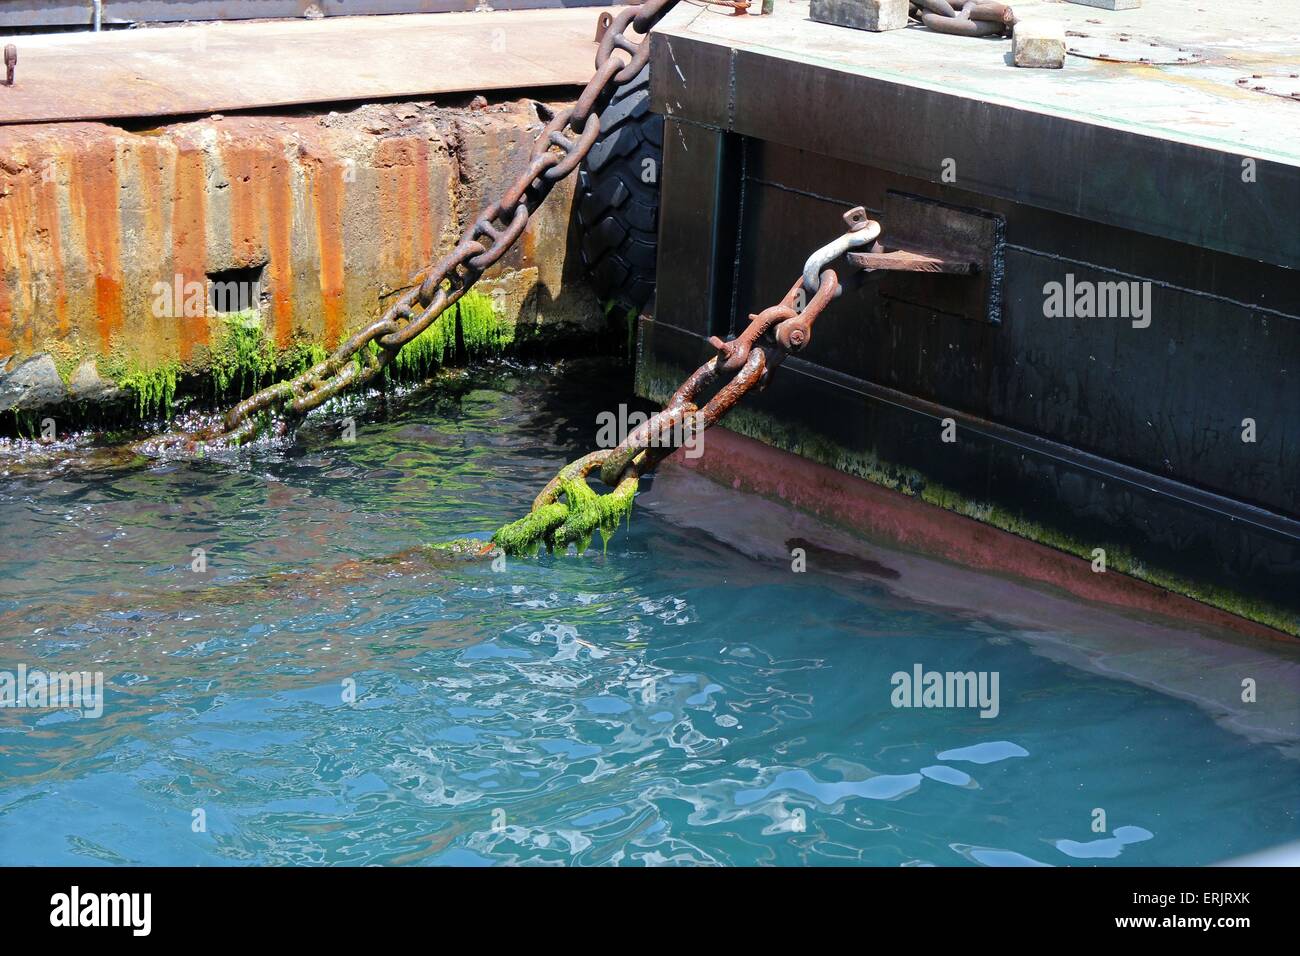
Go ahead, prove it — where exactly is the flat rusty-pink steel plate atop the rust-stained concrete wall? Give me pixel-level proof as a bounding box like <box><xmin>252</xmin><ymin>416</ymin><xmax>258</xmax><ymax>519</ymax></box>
<box><xmin>0</xmin><ymin>7</ymin><xmax>611</xmax><ymax>124</ymax></box>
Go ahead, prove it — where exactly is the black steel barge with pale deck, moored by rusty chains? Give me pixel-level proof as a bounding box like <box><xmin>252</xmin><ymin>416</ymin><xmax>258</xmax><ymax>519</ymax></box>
<box><xmin>637</xmin><ymin>0</ymin><xmax>1300</xmax><ymax>635</ymax></box>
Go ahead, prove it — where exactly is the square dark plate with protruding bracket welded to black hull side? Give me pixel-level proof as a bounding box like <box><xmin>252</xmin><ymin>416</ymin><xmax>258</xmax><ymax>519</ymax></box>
<box><xmin>879</xmin><ymin>190</ymin><xmax>1006</xmax><ymax>324</ymax></box>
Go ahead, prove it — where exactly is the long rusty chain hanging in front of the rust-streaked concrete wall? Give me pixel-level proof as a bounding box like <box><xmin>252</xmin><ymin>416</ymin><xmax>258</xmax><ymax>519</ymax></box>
<box><xmin>131</xmin><ymin>0</ymin><xmax>677</xmax><ymax>451</ymax></box>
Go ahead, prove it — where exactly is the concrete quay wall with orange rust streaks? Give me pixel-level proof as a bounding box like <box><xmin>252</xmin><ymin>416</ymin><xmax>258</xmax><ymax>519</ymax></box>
<box><xmin>0</xmin><ymin>100</ymin><xmax>603</xmax><ymax>411</ymax></box>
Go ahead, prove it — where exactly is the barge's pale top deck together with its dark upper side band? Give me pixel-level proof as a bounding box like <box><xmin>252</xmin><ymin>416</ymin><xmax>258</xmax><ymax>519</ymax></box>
<box><xmin>651</xmin><ymin>0</ymin><xmax>1300</xmax><ymax>269</ymax></box>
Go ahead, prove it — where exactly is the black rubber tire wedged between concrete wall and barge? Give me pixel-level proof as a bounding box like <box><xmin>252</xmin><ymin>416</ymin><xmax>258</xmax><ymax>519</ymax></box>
<box><xmin>577</xmin><ymin>65</ymin><xmax>663</xmax><ymax>311</ymax></box>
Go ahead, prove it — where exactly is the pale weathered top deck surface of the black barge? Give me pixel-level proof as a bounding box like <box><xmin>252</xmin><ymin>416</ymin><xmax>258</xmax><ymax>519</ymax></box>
<box><xmin>660</xmin><ymin>0</ymin><xmax>1300</xmax><ymax>164</ymax></box>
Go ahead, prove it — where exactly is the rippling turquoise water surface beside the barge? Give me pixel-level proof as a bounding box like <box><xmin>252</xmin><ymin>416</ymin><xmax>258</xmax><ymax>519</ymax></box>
<box><xmin>0</xmin><ymin>369</ymin><xmax>1300</xmax><ymax>866</ymax></box>
